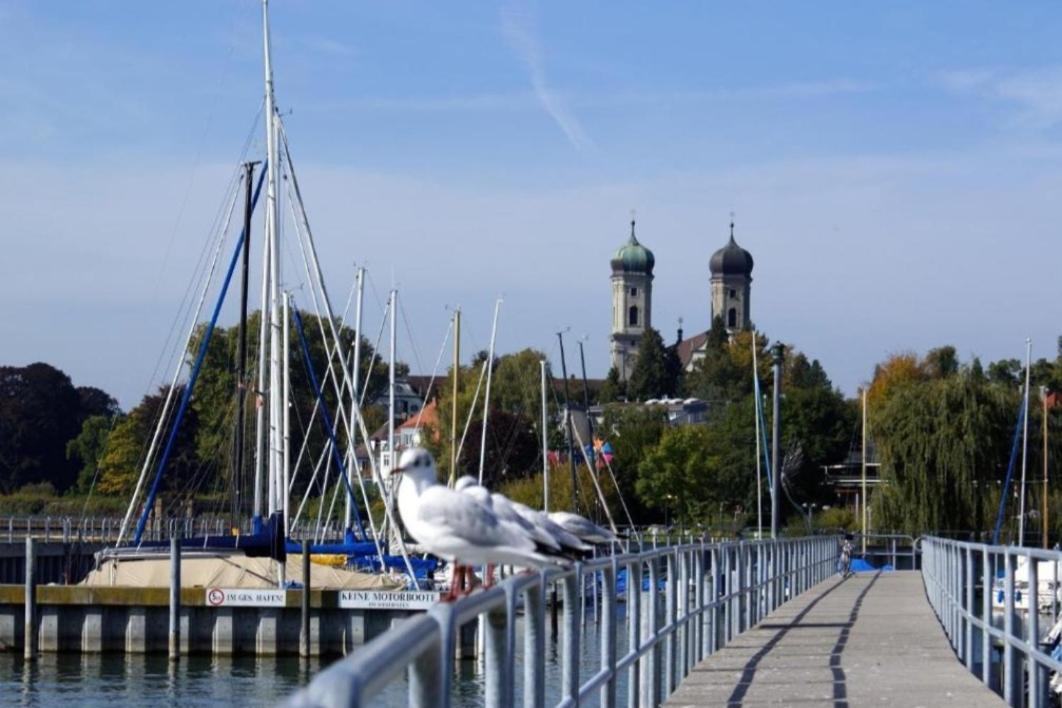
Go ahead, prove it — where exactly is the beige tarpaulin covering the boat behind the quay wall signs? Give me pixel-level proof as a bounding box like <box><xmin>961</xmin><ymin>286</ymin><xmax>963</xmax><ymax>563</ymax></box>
<box><xmin>81</xmin><ymin>555</ymin><xmax>406</xmax><ymax>590</ymax></box>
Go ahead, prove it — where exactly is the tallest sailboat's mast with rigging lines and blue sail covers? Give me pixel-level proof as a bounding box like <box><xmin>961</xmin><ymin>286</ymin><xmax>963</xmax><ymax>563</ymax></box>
<box><xmin>101</xmin><ymin>0</ymin><xmax>433</xmax><ymax>585</ymax></box>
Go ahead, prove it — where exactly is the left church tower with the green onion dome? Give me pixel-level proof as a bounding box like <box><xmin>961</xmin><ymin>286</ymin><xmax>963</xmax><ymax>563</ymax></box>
<box><xmin>609</xmin><ymin>220</ymin><xmax>656</xmax><ymax>381</ymax></box>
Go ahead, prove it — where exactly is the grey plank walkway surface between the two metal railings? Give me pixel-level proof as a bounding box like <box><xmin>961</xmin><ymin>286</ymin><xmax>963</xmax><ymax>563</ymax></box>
<box><xmin>666</xmin><ymin>571</ymin><xmax>1004</xmax><ymax>708</ymax></box>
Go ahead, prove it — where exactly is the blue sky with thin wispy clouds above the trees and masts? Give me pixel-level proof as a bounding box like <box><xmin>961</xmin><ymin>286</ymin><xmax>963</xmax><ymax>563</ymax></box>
<box><xmin>0</xmin><ymin>0</ymin><xmax>1062</xmax><ymax>405</ymax></box>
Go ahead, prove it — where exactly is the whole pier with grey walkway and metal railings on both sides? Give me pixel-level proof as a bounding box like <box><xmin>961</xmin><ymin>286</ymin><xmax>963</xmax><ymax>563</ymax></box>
<box><xmin>287</xmin><ymin>537</ymin><xmax>1062</xmax><ymax>708</ymax></box>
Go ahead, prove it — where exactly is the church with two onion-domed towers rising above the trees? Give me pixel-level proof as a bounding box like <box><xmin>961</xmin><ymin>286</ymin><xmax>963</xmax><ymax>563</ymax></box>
<box><xmin>610</xmin><ymin>221</ymin><xmax>753</xmax><ymax>381</ymax></box>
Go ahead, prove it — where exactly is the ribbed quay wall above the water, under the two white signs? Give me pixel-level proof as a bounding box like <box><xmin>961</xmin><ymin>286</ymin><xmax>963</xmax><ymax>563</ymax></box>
<box><xmin>0</xmin><ymin>585</ymin><xmax>415</xmax><ymax>656</ymax></box>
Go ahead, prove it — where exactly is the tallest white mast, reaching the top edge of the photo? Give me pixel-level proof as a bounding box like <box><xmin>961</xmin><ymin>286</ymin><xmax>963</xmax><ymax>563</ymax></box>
<box><xmin>262</xmin><ymin>0</ymin><xmax>284</xmax><ymax>514</ymax></box>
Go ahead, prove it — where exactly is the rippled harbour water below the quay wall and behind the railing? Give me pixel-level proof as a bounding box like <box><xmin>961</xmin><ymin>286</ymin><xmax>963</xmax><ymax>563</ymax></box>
<box><xmin>0</xmin><ymin>603</ymin><xmax>645</xmax><ymax>708</ymax></box>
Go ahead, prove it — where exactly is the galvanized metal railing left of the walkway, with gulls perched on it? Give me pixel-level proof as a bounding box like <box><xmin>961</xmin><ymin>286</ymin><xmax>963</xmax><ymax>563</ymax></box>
<box><xmin>288</xmin><ymin>536</ymin><xmax>839</xmax><ymax>708</ymax></box>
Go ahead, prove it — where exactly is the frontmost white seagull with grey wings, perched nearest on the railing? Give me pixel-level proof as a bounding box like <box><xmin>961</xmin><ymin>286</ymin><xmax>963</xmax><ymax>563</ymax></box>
<box><xmin>394</xmin><ymin>448</ymin><xmax>564</xmax><ymax>591</ymax></box>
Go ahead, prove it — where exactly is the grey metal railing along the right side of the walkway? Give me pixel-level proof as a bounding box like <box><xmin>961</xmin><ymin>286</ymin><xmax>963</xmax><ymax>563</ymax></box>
<box><xmin>922</xmin><ymin>537</ymin><xmax>1062</xmax><ymax>707</ymax></box>
